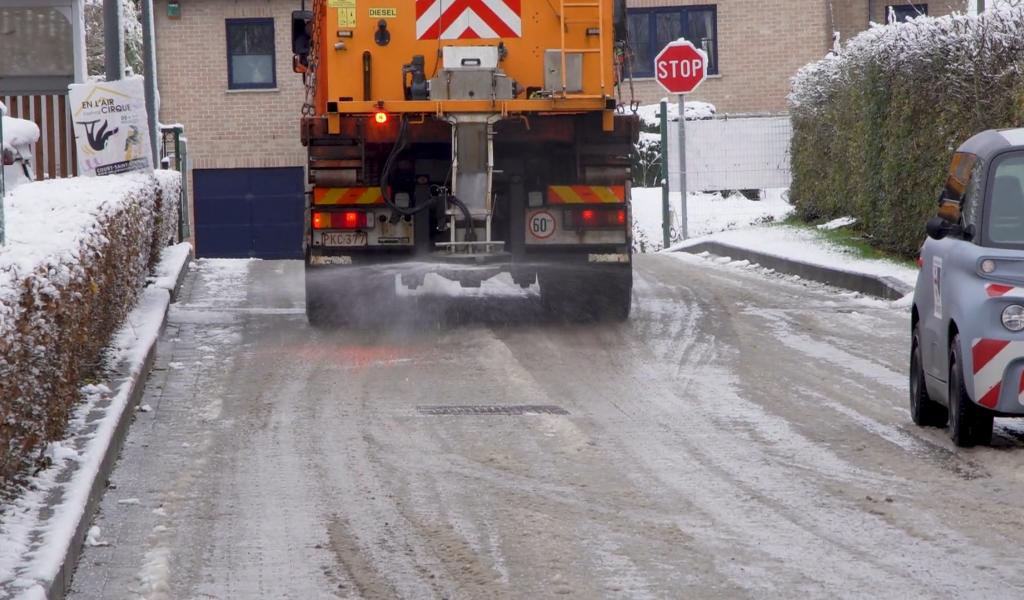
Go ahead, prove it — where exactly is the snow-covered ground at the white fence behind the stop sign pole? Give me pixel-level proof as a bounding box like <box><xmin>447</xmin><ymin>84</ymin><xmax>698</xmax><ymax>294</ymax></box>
<box><xmin>632</xmin><ymin>187</ymin><xmax>793</xmax><ymax>252</ymax></box>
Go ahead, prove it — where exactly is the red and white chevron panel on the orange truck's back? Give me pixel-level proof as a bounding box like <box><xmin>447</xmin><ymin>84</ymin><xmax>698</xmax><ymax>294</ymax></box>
<box><xmin>416</xmin><ymin>0</ymin><xmax>522</xmax><ymax>40</ymax></box>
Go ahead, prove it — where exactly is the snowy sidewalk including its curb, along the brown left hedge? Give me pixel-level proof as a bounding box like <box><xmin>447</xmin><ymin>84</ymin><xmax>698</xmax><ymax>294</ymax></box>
<box><xmin>0</xmin><ymin>244</ymin><xmax>191</xmax><ymax>600</ymax></box>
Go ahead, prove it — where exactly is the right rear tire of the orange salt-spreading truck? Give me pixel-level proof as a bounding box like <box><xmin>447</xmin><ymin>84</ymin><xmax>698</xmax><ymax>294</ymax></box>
<box><xmin>538</xmin><ymin>265</ymin><xmax>633</xmax><ymax>323</ymax></box>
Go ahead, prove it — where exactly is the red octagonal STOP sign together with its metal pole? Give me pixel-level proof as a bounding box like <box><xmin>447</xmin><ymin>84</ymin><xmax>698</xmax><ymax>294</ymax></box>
<box><xmin>654</xmin><ymin>39</ymin><xmax>708</xmax><ymax>241</ymax></box>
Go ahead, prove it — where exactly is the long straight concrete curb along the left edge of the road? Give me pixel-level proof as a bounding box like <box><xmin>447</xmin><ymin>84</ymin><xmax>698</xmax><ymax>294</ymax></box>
<box><xmin>46</xmin><ymin>245</ymin><xmax>193</xmax><ymax>600</ymax></box>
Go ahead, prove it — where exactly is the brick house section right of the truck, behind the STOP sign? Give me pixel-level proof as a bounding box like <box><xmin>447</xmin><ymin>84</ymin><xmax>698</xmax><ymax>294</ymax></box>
<box><xmin>627</xmin><ymin>0</ymin><xmax>967</xmax><ymax>114</ymax></box>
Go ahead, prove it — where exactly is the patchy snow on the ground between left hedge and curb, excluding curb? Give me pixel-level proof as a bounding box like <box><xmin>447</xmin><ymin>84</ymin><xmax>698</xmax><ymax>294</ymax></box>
<box><xmin>0</xmin><ymin>287</ymin><xmax>169</xmax><ymax>597</ymax></box>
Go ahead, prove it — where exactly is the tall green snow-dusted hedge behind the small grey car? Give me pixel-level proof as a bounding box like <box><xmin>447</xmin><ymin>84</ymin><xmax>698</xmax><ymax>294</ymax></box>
<box><xmin>790</xmin><ymin>9</ymin><xmax>1024</xmax><ymax>256</ymax></box>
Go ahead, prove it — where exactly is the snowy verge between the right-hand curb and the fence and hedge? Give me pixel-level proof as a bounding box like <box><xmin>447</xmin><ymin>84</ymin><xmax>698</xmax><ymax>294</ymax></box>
<box><xmin>670</xmin><ymin>225</ymin><xmax>918</xmax><ymax>287</ymax></box>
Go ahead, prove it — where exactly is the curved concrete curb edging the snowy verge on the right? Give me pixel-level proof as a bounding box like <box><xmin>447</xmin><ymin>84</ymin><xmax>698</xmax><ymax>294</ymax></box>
<box><xmin>679</xmin><ymin>241</ymin><xmax>913</xmax><ymax>300</ymax></box>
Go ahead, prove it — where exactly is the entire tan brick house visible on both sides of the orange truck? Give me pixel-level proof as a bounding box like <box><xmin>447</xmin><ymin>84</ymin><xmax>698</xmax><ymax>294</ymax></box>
<box><xmin>154</xmin><ymin>0</ymin><xmax>966</xmax><ymax>258</ymax></box>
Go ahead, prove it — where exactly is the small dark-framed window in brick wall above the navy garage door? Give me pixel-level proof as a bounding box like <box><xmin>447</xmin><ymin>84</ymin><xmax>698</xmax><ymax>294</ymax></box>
<box><xmin>227</xmin><ymin>18</ymin><xmax>278</xmax><ymax>89</ymax></box>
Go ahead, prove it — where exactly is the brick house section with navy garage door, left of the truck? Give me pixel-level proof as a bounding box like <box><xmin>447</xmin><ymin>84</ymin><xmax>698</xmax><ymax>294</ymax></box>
<box><xmin>154</xmin><ymin>0</ymin><xmax>306</xmax><ymax>258</ymax></box>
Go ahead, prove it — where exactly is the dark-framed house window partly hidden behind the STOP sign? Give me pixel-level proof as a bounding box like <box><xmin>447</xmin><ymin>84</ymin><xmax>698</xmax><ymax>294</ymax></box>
<box><xmin>627</xmin><ymin>6</ymin><xmax>718</xmax><ymax>77</ymax></box>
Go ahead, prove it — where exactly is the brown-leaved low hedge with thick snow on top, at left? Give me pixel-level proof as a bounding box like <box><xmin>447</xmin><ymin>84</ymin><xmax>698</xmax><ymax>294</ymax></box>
<box><xmin>0</xmin><ymin>167</ymin><xmax>180</xmax><ymax>481</ymax></box>
